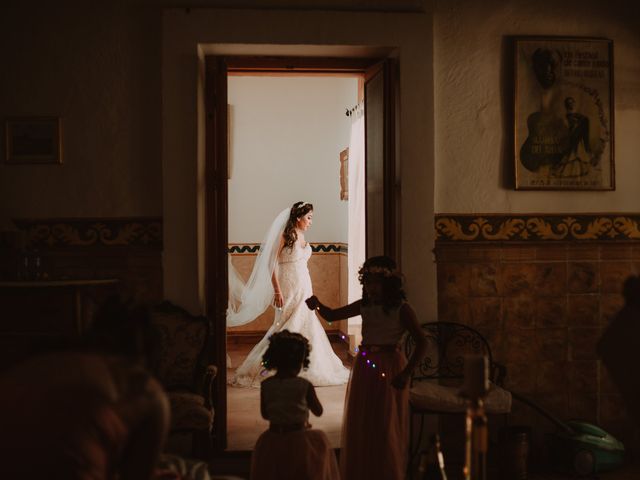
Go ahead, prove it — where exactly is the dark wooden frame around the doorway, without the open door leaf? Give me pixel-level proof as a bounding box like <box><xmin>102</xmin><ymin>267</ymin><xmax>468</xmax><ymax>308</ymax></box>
<box><xmin>204</xmin><ymin>55</ymin><xmax>399</xmax><ymax>454</ymax></box>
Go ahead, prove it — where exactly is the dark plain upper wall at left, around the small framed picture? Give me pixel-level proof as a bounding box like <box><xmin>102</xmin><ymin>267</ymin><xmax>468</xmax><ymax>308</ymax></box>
<box><xmin>0</xmin><ymin>2</ymin><xmax>162</xmax><ymax>223</ymax></box>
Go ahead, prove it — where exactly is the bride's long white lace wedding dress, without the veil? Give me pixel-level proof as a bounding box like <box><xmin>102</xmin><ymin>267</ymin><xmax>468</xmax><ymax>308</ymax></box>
<box><xmin>231</xmin><ymin>242</ymin><xmax>349</xmax><ymax>387</ymax></box>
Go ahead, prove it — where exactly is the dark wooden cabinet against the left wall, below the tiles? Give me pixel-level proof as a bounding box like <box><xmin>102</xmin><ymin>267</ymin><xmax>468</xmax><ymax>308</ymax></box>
<box><xmin>0</xmin><ymin>279</ymin><xmax>118</xmax><ymax>369</ymax></box>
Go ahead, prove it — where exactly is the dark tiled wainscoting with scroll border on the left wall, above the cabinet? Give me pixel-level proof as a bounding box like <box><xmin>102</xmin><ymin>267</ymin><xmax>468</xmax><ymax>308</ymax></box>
<box><xmin>2</xmin><ymin>217</ymin><xmax>162</xmax><ymax>303</ymax></box>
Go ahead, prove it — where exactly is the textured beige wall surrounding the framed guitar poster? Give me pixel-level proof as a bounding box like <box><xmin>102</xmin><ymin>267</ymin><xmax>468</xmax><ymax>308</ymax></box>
<box><xmin>434</xmin><ymin>0</ymin><xmax>640</xmax><ymax>213</ymax></box>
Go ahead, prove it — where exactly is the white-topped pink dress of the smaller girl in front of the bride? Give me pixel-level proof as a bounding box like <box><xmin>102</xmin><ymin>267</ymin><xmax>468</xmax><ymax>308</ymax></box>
<box><xmin>251</xmin><ymin>376</ymin><xmax>340</xmax><ymax>480</ymax></box>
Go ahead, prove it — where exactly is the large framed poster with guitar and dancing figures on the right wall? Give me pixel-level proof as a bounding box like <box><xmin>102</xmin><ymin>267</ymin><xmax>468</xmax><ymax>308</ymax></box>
<box><xmin>514</xmin><ymin>37</ymin><xmax>615</xmax><ymax>190</ymax></box>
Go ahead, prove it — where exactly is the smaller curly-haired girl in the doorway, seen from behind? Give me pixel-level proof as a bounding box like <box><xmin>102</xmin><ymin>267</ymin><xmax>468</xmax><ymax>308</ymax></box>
<box><xmin>251</xmin><ymin>330</ymin><xmax>340</xmax><ymax>480</ymax></box>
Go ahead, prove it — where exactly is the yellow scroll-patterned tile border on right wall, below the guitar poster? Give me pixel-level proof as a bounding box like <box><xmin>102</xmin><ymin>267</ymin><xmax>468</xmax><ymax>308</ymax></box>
<box><xmin>435</xmin><ymin>213</ymin><xmax>640</xmax><ymax>244</ymax></box>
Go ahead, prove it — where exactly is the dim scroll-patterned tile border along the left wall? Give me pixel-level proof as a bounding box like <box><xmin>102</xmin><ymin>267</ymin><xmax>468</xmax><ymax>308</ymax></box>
<box><xmin>13</xmin><ymin>217</ymin><xmax>162</xmax><ymax>249</ymax></box>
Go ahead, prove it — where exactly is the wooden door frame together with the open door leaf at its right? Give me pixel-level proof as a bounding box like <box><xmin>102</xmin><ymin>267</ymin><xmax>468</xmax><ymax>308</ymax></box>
<box><xmin>204</xmin><ymin>57</ymin><xmax>399</xmax><ymax>451</ymax></box>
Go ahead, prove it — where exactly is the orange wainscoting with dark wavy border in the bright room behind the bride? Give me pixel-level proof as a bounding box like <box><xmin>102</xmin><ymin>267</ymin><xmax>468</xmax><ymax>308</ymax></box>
<box><xmin>228</xmin><ymin>243</ymin><xmax>347</xmax><ymax>337</ymax></box>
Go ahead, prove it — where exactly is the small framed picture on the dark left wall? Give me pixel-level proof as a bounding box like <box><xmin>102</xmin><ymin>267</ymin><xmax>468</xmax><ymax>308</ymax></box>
<box><xmin>5</xmin><ymin>117</ymin><xmax>62</xmax><ymax>164</ymax></box>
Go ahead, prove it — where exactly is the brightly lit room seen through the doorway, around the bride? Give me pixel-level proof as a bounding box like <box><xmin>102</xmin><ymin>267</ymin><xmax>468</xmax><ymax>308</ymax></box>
<box><xmin>227</xmin><ymin>72</ymin><xmax>365</xmax><ymax>451</ymax></box>
